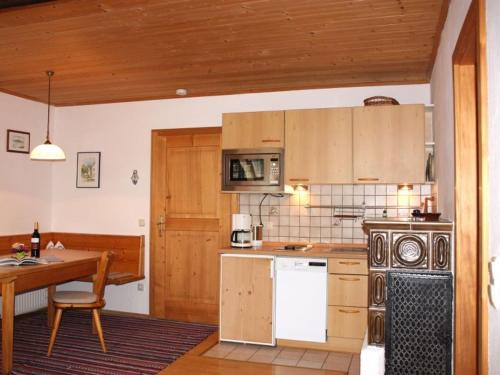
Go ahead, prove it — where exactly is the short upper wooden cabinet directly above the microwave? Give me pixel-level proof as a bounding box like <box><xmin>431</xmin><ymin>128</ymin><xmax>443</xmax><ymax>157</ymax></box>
<box><xmin>222</xmin><ymin>111</ymin><xmax>285</xmax><ymax>149</ymax></box>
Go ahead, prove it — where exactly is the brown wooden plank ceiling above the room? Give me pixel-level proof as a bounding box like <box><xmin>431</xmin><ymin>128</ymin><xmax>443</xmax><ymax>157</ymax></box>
<box><xmin>0</xmin><ymin>0</ymin><xmax>449</xmax><ymax>106</ymax></box>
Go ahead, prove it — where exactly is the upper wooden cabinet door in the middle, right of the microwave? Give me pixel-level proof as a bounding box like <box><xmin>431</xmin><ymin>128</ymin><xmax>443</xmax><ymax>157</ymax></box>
<box><xmin>285</xmin><ymin>108</ymin><xmax>352</xmax><ymax>185</ymax></box>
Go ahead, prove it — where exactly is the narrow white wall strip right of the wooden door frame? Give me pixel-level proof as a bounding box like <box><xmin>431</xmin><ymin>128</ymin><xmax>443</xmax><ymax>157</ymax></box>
<box><xmin>486</xmin><ymin>0</ymin><xmax>500</xmax><ymax>374</ymax></box>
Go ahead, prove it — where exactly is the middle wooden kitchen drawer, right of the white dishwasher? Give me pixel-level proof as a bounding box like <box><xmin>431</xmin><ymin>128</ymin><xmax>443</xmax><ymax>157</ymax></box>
<box><xmin>328</xmin><ymin>275</ymin><xmax>368</xmax><ymax>307</ymax></box>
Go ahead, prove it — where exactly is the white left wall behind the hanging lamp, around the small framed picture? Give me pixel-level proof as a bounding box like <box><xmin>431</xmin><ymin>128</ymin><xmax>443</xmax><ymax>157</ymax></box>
<box><xmin>0</xmin><ymin>93</ymin><xmax>52</xmax><ymax>235</ymax></box>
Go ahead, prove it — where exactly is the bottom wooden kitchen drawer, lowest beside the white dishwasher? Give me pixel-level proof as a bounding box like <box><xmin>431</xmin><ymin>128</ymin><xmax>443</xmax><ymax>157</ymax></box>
<box><xmin>328</xmin><ymin>306</ymin><xmax>368</xmax><ymax>339</ymax></box>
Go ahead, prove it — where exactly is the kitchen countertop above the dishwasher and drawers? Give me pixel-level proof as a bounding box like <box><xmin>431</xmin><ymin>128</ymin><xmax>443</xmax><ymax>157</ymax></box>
<box><xmin>219</xmin><ymin>243</ymin><xmax>368</xmax><ymax>259</ymax></box>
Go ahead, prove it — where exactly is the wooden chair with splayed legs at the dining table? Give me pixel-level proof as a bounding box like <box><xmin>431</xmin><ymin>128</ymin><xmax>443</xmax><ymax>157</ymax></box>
<box><xmin>47</xmin><ymin>251</ymin><xmax>111</xmax><ymax>357</ymax></box>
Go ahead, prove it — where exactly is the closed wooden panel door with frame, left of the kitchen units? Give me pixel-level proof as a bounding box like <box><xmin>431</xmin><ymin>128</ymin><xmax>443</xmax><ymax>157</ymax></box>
<box><xmin>150</xmin><ymin>128</ymin><xmax>237</xmax><ymax>323</ymax></box>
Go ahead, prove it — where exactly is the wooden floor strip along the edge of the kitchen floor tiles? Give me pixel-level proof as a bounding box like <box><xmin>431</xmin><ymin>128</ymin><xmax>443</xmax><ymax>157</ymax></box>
<box><xmin>159</xmin><ymin>333</ymin><xmax>359</xmax><ymax>375</ymax></box>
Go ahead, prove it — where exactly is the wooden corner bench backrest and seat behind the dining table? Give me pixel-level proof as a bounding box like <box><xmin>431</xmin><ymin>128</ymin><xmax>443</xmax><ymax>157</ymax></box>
<box><xmin>0</xmin><ymin>232</ymin><xmax>144</xmax><ymax>285</ymax></box>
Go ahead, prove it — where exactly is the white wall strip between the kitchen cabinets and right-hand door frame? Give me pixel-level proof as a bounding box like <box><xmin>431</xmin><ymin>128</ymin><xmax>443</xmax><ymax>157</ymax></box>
<box><xmin>431</xmin><ymin>0</ymin><xmax>471</xmax><ymax>220</ymax></box>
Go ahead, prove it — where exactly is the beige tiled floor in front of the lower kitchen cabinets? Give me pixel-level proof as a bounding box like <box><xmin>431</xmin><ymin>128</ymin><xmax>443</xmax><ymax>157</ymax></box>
<box><xmin>203</xmin><ymin>342</ymin><xmax>359</xmax><ymax>375</ymax></box>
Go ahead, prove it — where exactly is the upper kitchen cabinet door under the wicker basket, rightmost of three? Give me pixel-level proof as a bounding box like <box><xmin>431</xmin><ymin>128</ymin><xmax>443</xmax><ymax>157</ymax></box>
<box><xmin>353</xmin><ymin>104</ymin><xmax>425</xmax><ymax>183</ymax></box>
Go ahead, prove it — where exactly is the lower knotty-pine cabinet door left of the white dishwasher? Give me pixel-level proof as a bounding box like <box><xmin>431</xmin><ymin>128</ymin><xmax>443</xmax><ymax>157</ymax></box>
<box><xmin>220</xmin><ymin>255</ymin><xmax>274</xmax><ymax>344</ymax></box>
